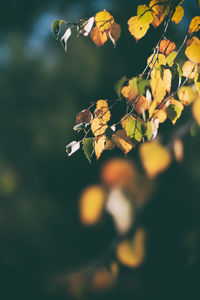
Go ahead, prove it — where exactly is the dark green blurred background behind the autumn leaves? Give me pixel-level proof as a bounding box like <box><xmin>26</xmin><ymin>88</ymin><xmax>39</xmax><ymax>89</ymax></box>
<box><xmin>0</xmin><ymin>0</ymin><xmax>200</xmax><ymax>300</ymax></box>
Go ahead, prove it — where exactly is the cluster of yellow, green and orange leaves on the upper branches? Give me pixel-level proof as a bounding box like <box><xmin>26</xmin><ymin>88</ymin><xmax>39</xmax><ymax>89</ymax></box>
<box><xmin>53</xmin><ymin>0</ymin><xmax>200</xmax><ymax>177</ymax></box>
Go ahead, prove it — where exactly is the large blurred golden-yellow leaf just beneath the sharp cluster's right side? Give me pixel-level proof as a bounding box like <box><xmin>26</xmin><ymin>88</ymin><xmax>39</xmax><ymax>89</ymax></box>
<box><xmin>139</xmin><ymin>141</ymin><xmax>171</xmax><ymax>178</ymax></box>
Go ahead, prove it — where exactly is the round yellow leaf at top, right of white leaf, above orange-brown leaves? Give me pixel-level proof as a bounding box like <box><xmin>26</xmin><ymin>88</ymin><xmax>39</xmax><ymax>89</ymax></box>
<box><xmin>95</xmin><ymin>10</ymin><xmax>114</xmax><ymax>31</ymax></box>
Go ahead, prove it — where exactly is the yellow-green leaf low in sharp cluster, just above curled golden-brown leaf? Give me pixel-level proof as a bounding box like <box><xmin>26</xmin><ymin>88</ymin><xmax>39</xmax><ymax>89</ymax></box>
<box><xmin>125</xmin><ymin>119</ymin><xmax>144</xmax><ymax>142</ymax></box>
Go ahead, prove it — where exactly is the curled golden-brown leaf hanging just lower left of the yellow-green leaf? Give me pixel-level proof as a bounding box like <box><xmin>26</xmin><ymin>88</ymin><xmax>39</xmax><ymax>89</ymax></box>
<box><xmin>113</xmin><ymin>129</ymin><xmax>133</xmax><ymax>154</ymax></box>
